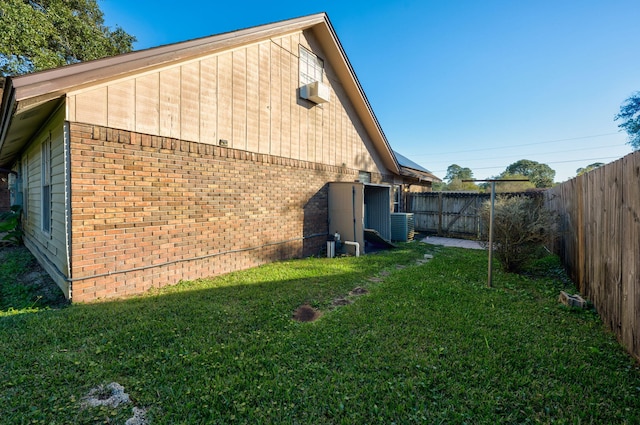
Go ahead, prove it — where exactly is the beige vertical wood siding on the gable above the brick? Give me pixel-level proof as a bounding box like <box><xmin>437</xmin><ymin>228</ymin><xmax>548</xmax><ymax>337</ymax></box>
<box><xmin>67</xmin><ymin>31</ymin><xmax>385</xmax><ymax>173</ymax></box>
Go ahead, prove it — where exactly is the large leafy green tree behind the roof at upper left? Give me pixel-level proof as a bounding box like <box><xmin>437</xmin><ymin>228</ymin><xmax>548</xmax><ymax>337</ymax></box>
<box><xmin>0</xmin><ymin>0</ymin><xmax>136</xmax><ymax>76</ymax></box>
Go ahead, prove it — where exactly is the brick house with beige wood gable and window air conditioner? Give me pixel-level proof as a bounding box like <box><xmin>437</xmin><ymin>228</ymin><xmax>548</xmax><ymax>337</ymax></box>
<box><xmin>0</xmin><ymin>13</ymin><xmax>436</xmax><ymax>302</ymax></box>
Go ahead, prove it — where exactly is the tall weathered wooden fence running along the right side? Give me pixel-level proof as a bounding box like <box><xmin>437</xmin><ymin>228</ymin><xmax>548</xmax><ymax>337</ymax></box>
<box><xmin>545</xmin><ymin>152</ymin><xmax>640</xmax><ymax>359</ymax></box>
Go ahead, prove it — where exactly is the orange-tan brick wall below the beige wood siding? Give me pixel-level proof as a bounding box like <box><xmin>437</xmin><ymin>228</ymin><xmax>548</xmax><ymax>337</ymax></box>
<box><xmin>70</xmin><ymin>123</ymin><xmax>381</xmax><ymax>301</ymax></box>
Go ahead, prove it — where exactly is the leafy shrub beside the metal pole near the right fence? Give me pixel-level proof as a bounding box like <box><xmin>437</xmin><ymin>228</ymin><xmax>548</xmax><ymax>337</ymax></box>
<box><xmin>481</xmin><ymin>196</ymin><xmax>556</xmax><ymax>273</ymax></box>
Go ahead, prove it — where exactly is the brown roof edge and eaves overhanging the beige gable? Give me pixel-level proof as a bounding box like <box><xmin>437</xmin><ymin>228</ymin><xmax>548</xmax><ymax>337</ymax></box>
<box><xmin>0</xmin><ymin>13</ymin><xmax>400</xmax><ymax>174</ymax></box>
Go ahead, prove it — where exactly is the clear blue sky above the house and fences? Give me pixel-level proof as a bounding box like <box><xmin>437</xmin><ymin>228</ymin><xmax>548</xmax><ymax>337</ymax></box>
<box><xmin>99</xmin><ymin>0</ymin><xmax>640</xmax><ymax>181</ymax></box>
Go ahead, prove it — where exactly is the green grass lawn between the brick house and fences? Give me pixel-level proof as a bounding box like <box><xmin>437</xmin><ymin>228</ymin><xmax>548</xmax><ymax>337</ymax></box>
<box><xmin>0</xmin><ymin>243</ymin><xmax>640</xmax><ymax>424</ymax></box>
